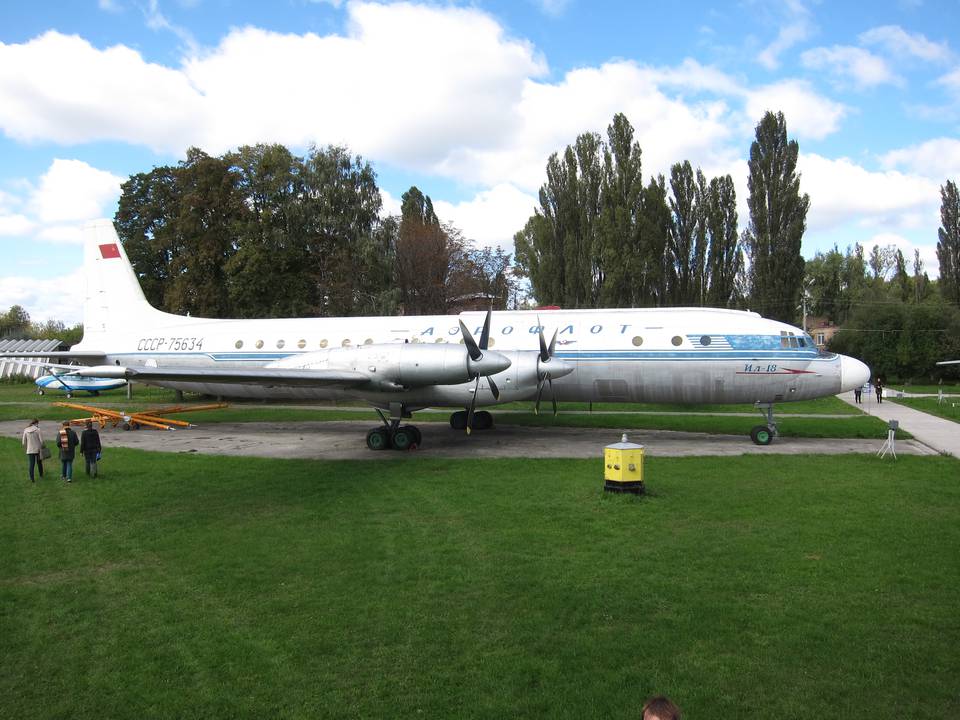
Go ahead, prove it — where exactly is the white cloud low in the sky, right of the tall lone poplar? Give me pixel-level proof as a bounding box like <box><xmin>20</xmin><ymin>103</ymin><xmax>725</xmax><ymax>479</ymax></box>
<box><xmin>798</xmin><ymin>153</ymin><xmax>940</xmax><ymax>232</ymax></box>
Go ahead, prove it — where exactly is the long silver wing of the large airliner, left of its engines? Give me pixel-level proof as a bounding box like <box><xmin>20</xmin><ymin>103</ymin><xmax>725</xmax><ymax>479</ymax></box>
<box><xmin>67</xmin><ymin>365</ymin><xmax>371</xmax><ymax>387</ymax></box>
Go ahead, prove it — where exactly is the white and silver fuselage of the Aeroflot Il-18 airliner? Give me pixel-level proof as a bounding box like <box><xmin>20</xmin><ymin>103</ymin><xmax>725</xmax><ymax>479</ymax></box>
<box><xmin>75</xmin><ymin>308</ymin><xmax>856</xmax><ymax>408</ymax></box>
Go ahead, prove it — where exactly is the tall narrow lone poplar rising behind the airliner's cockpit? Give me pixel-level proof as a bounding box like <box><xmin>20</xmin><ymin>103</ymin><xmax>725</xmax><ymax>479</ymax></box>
<box><xmin>747</xmin><ymin>112</ymin><xmax>810</xmax><ymax>322</ymax></box>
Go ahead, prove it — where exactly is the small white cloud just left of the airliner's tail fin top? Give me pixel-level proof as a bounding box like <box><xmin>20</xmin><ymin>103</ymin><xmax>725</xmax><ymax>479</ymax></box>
<box><xmin>29</xmin><ymin>159</ymin><xmax>126</xmax><ymax>225</ymax></box>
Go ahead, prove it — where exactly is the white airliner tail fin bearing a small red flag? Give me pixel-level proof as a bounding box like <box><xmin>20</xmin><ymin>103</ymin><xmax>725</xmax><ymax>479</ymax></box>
<box><xmin>83</xmin><ymin>220</ymin><xmax>164</xmax><ymax>339</ymax></box>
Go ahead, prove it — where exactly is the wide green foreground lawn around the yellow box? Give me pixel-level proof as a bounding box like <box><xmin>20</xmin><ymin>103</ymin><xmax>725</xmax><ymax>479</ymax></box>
<box><xmin>0</xmin><ymin>439</ymin><xmax>960</xmax><ymax>720</ymax></box>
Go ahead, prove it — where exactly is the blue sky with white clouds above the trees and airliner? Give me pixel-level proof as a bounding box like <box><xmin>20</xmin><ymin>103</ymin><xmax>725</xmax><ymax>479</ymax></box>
<box><xmin>0</xmin><ymin>0</ymin><xmax>960</xmax><ymax>325</ymax></box>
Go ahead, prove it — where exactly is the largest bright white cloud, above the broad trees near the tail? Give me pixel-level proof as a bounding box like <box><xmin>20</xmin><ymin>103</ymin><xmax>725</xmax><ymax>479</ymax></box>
<box><xmin>177</xmin><ymin>3</ymin><xmax>546</xmax><ymax>164</ymax></box>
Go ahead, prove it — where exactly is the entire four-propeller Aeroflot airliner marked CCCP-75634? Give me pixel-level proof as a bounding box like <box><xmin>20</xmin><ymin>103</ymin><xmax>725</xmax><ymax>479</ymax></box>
<box><xmin>0</xmin><ymin>220</ymin><xmax>870</xmax><ymax>450</ymax></box>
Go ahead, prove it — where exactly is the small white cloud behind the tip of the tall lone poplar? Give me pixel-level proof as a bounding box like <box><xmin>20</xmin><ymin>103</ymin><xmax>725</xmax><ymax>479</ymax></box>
<box><xmin>746</xmin><ymin>80</ymin><xmax>849</xmax><ymax>140</ymax></box>
